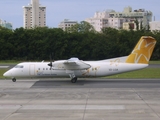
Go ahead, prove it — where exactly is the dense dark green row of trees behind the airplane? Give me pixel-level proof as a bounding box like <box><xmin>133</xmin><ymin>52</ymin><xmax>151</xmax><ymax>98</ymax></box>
<box><xmin>0</xmin><ymin>25</ymin><xmax>160</xmax><ymax>60</ymax></box>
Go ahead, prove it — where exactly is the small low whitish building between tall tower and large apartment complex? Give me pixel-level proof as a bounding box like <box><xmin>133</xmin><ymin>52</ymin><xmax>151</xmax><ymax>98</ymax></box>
<box><xmin>58</xmin><ymin>19</ymin><xmax>78</xmax><ymax>30</ymax></box>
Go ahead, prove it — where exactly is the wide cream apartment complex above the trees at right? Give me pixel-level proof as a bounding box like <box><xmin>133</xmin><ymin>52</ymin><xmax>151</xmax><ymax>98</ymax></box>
<box><xmin>85</xmin><ymin>7</ymin><xmax>152</xmax><ymax>32</ymax></box>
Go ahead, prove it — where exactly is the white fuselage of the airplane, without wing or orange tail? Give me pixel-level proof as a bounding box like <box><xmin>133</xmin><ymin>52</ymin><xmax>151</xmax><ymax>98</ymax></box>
<box><xmin>4</xmin><ymin>60</ymin><xmax>148</xmax><ymax>77</ymax></box>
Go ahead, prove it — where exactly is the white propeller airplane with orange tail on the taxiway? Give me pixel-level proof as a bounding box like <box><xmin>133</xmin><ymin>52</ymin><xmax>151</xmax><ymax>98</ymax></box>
<box><xmin>3</xmin><ymin>36</ymin><xmax>156</xmax><ymax>83</ymax></box>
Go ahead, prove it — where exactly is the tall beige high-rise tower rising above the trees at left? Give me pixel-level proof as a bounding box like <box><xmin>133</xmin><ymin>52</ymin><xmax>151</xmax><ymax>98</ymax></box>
<box><xmin>23</xmin><ymin>0</ymin><xmax>46</xmax><ymax>28</ymax></box>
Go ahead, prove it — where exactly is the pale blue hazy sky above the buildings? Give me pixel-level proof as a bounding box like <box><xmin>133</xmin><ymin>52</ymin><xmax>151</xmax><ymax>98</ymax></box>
<box><xmin>0</xmin><ymin>0</ymin><xmax>160</xmax><ymax>29</ymax></box>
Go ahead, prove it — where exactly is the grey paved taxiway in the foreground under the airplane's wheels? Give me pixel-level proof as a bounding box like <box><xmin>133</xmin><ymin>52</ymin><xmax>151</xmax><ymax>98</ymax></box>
<box><xmin>0</xmin><ymin>78</ymin><xmax>160</xmax><ymax>120</ymax></box>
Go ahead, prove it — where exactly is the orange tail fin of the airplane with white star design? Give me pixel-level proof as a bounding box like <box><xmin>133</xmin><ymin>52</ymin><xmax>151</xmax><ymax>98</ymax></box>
<box><xmin>126</xmin><ymin>36</ymin><xmax>156</xmax><ymax>64</ymax></box>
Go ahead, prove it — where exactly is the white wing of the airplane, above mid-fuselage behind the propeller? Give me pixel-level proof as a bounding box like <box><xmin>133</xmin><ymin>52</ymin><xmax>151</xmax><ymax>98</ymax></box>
<box><xmin>63</xmin><ymin>58</ymin><xmax>91</xmax><ymax>70</ymax></box>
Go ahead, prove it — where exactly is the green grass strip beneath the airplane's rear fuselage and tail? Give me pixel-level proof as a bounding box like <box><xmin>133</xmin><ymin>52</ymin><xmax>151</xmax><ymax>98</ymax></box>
<box><xmin>105</xmin><ymin>68</ymin><xmax>160</xmax><ymax>79</ymax></box>
